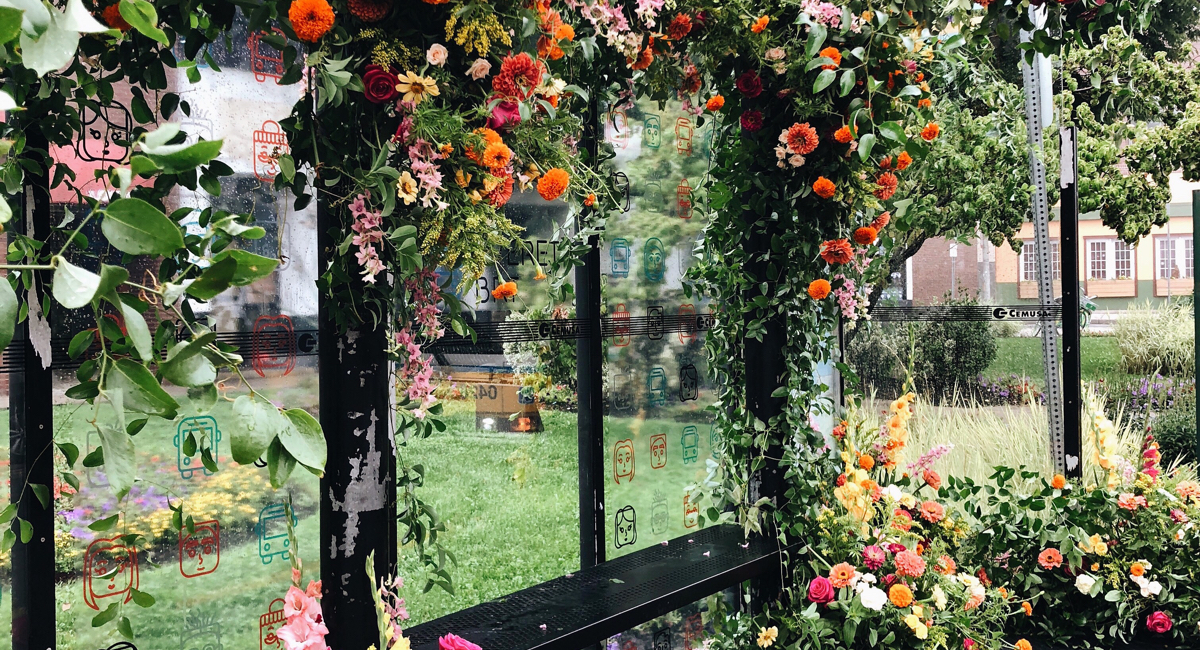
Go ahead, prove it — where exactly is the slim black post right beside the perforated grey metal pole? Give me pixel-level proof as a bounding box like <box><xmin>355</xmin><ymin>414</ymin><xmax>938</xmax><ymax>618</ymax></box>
<box><xmin>1058</xmin><ymin>125</ymin><xmax>1084</xmax><ymax>477</ymax></box>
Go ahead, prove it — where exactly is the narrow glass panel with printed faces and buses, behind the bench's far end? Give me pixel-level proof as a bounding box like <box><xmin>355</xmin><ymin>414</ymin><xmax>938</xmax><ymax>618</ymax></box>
<box><xmin>600</xmin><ymin>101</ymin><xmax>715</xmax><ymax>558</ymax></box>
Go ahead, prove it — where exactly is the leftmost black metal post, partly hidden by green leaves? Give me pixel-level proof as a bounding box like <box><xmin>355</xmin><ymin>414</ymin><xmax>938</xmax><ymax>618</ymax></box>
<box><xmin>10</xmin><ymin>155</ymin><xmax>56</xmax><ymax>650</ymax></box>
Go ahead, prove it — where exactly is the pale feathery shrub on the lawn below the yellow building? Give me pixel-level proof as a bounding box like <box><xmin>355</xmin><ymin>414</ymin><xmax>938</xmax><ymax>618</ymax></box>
<box><xmin>1112</xmin><ymin>302</ymin><xmax>1196</xmax><ymax>377</ymax></box>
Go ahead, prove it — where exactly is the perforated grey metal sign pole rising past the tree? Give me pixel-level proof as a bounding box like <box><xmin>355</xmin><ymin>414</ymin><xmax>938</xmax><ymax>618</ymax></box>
<box><xmin>1021</xmin><ymin>15</ymin><xmax>1067</xmax><ymax>470</ymax></box>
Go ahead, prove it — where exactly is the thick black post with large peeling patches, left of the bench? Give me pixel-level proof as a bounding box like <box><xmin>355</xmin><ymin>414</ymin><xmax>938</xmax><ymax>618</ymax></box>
<box><xmin>317</xmin><ymin>200</ymin><xmax>396</xmax><ymax>650</ymax></box>
